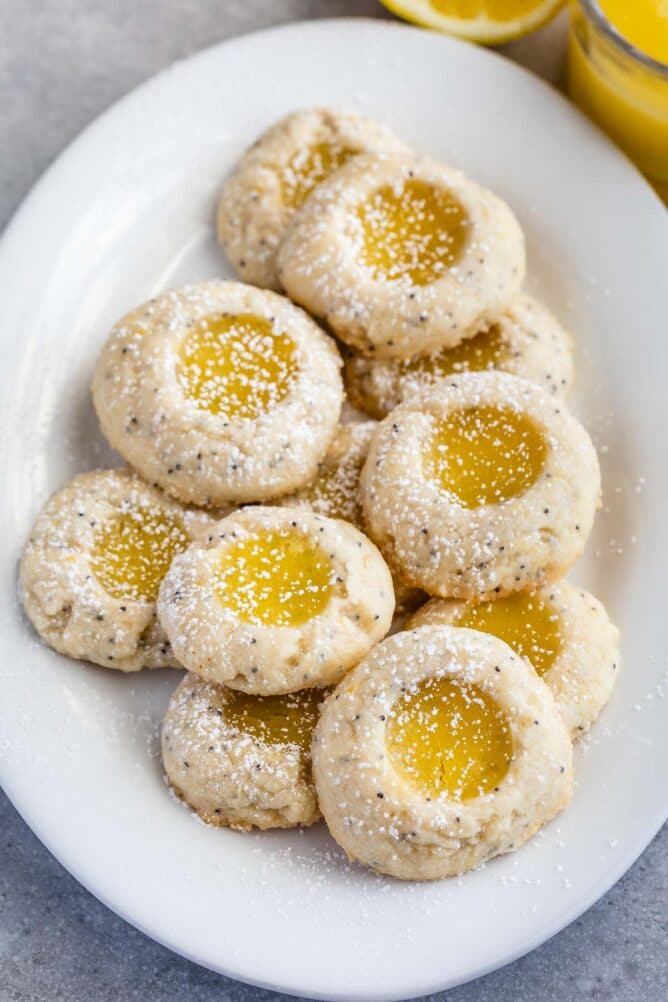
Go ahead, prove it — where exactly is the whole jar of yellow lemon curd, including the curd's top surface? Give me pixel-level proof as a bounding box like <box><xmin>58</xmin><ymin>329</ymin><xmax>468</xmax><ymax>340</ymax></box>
<box><xmin>568</xmin><ymin>0</ymin><xmax>668</xmax><ymax>200</ymax></box>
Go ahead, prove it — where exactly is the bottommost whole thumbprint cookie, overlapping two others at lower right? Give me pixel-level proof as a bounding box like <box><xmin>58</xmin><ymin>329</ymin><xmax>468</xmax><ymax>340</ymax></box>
<box><xmin>313</xmin><ymin>626</ymin><xmax>573</xmax><ymax>880</ymax></box>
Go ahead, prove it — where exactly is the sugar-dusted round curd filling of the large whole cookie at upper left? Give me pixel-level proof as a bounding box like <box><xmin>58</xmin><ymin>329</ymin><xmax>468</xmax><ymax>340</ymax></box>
<box><xmin>176</xmin><ymin>314</ymin><xmax>297</xmax><ymax>419</ymax></box>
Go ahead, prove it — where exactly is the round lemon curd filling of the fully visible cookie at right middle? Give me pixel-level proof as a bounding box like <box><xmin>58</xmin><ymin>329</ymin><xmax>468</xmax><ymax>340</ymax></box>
<box><xmin>423</xmin><ymin>405</ymin><xmax>548</xmax><ymax>508</ymax></box>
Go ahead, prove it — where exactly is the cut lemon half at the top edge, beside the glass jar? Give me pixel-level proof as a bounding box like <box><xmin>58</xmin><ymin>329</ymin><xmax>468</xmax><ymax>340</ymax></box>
<box><xmin>381</xmin><ymin>0</ymin><xmax>564</xmax><ymax>45</ymax></box>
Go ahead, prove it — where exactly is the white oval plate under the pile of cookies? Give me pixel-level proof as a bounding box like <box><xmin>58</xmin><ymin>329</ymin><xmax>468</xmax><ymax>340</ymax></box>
<box><xmin>0</xmin><ymin>21</ymin><xmax>668</xmax><ymax>1000</ymax></box>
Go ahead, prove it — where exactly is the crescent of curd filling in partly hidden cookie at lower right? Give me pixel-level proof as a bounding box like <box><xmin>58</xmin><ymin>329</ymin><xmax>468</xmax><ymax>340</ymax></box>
<box><xmin>453</xmin><ymin>592</ymin><xmax>564</xmax><ymax>676</ymax></box>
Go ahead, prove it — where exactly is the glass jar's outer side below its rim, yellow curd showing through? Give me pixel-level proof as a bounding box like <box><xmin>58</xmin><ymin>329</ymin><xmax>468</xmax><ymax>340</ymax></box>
<box><xmin>568</xmin><ymin>0</ymin><xmax>668</xmax><ymax>202</ymax></box>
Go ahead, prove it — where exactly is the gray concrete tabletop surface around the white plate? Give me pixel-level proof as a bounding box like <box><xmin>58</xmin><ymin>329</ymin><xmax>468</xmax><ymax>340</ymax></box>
<box><xmin>0</xmin><ymin>0</ymin><xmax>668</xmax><ymax>1002</ymax></box>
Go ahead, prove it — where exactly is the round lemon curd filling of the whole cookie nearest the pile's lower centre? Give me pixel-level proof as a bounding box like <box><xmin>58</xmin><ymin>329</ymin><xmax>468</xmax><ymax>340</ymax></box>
<box><xmin>214</xmin><ymin>529</ymin><xmax>336</xmax><ymax>626</ymax></box>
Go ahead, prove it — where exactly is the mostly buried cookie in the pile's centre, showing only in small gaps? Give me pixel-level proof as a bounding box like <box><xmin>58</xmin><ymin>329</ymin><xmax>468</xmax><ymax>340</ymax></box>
<box><xmin>281</xmin><ymin>421</ymin><xmax>427</xmax><ymax>623</ymax></box>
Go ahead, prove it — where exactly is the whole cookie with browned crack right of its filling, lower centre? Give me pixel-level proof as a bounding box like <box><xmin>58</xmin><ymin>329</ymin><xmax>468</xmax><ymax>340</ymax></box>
<box><xmin>158</xmin><ymin>507</ymin><xmax>395</xmax><ymax>695</ymax></box>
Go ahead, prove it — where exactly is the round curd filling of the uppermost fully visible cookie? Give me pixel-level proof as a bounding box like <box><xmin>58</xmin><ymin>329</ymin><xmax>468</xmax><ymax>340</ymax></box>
<box><xmin>357</xmin><ymin>180</ymin><xmax>470</xmax><ymax>286</ymax></box>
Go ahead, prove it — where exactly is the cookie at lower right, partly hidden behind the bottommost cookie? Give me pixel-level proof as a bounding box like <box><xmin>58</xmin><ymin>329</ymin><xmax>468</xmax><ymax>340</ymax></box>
<box><xmin>407</xmin><ymin>581</ymin><xmax>620</xmax><ymax>739</ymax></box>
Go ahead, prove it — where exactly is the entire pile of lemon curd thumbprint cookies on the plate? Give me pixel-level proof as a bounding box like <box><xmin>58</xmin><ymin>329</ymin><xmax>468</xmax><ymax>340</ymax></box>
<box><xmin>21</xmin><ymin>109</ymin><xmax>619</xmax><ymax>879</ymax></box>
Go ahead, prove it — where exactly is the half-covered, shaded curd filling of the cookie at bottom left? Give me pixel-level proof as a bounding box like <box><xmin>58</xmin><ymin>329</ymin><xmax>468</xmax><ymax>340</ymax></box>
<box><xmin>223</xmin><ymin>689</ymin><xmax>326</xmax><ymax>753</ymax></box>
